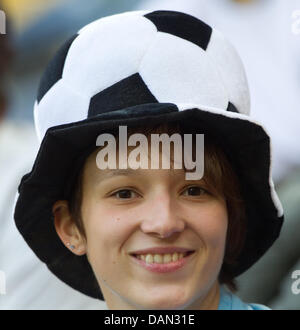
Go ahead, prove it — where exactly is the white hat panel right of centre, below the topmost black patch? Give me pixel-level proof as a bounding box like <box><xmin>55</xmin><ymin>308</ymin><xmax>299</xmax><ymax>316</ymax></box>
<box><xmin>139</xmin><ymin>32</ymin><xmax>228</xmax><ymax>109</ymax></box>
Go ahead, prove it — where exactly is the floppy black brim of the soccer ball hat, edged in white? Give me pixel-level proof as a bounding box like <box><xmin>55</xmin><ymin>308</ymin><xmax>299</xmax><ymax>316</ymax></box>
<box><xmin>14</xmin><ymin>103</ymin><xmax>283</xmax><ymax>300</ymax></box>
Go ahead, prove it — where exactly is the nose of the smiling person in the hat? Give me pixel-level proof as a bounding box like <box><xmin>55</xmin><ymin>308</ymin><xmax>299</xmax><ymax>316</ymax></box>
<box><xmin>141</xmin><ymin>192</ymin><xmax>186</xmax><ymax>238</ymax></box>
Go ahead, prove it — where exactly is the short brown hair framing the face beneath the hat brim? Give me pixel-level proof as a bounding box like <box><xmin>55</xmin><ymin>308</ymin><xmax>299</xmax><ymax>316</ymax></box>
<box><xmin>69</xmin><ymin>123</ymin><xmax>246</xmax><ymax>291</ymax></box>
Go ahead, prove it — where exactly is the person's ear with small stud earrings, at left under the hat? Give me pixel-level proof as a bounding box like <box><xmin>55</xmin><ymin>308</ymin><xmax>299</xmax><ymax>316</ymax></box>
<box><xmin>52</xmin><ymin>200</ymin><xmax>86</xmax><ymax>255</ymax></box>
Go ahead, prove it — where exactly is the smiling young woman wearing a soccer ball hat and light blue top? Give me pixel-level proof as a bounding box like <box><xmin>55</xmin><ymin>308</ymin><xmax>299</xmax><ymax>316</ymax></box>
<box><xmin>15</xmin><ymin>11</ymin><xmax>283</xmax><ymax>309</ymax></box>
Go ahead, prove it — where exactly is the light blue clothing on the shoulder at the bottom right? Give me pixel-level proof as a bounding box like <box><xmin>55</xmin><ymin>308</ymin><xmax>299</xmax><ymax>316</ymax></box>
<box><xmin>218</xmin><ymin>286</ymin><xmax>270</xmax><ymax>310</ymax></box>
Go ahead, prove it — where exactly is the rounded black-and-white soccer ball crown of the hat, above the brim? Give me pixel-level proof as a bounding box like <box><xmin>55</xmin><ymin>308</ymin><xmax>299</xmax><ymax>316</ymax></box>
<box><xmin>34</xmin><ymin>11</ymin><xmax>250</xmax><ymax>140</ymax></box>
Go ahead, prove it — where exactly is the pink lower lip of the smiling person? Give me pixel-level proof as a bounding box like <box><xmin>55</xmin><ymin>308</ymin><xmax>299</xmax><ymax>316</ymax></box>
<box><xmin>130</xmin><ymin>250</ymin><xmax>195</xmax><ymax>273</ymax></box>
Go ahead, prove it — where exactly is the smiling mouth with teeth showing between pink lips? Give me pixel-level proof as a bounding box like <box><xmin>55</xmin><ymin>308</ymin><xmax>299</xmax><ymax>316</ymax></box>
<box><xmin>130</xmin><ymin>250</ymin><xmax>195</xmax><ymax>273</ymax></box>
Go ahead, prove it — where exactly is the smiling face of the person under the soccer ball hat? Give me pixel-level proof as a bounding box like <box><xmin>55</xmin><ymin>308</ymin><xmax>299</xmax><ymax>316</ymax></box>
<box><xmin>54</xmin><ymin>130</ymin><xmax>228</xmax><ymax>309</ymax></box>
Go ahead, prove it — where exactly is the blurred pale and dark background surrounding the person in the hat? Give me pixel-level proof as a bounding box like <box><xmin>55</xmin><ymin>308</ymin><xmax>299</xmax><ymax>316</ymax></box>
<box><xmin>0</xmin><ymin>0</ymin><xmax>300</xmax><ymax>309</ymax></box>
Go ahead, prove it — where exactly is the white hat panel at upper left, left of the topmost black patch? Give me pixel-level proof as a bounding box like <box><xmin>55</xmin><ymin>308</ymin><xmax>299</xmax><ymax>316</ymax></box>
<box><xmin>63</xmin><ymin>15</ymin><xmax>157</xmax><ymax>97</ymax></box>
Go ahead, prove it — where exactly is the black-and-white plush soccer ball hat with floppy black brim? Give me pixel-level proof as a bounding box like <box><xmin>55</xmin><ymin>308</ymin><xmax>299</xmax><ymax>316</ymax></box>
<box><xmin>15</xmin><ymin>11</ymin><xmax>283</xmax><ymax>299</ymax></box>
